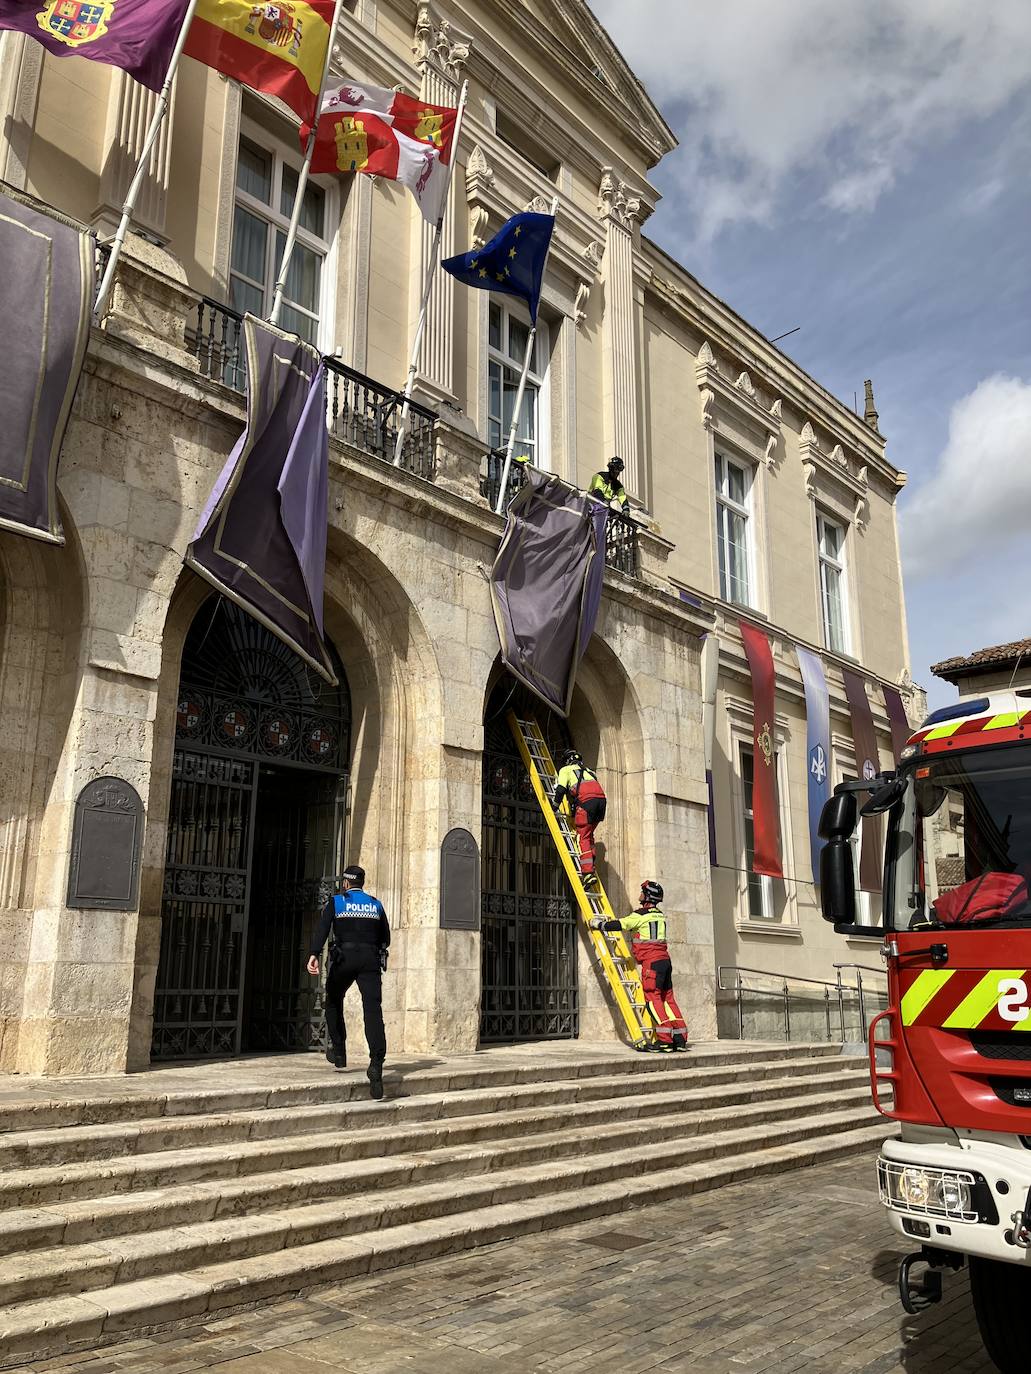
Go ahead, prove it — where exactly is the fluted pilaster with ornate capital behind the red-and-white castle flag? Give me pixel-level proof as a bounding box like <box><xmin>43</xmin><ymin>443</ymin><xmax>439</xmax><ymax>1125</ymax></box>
<box><xmin>410</xmin><ymin>0</ymin><xmax>470</xmax><ymax>401</ymax></box>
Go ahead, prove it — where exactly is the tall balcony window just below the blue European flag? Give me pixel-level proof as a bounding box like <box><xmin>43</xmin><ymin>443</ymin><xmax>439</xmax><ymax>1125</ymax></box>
<box><xmin>487</xmin><ymin>301</ymin><xmax>548</xmax><ymax>470</ymax></box>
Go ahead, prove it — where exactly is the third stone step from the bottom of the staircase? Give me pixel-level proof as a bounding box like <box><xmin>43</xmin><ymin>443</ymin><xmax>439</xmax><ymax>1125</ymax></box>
<box><xmin>0</xmin><ymin>1085</ymin><xmax>870</xmax><ymax>1256</ymax></box>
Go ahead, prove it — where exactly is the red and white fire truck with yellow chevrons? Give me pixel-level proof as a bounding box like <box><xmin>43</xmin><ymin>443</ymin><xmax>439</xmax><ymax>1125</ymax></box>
<box><xmin>821</xmin><ymin>691</ymin><xmax>1031</xmax><ymax>1374</ymax></box>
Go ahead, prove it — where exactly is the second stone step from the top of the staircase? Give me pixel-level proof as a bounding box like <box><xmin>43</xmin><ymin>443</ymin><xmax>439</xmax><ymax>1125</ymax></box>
<box><xmin>0</xmin><ymin>1058</ymin><xmax>866</xmax><ymax>1173</ymax></box>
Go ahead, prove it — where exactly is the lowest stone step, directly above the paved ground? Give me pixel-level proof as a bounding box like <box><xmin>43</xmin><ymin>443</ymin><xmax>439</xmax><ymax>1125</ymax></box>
<box><xmin>0</xmin><ymin>1118</ymin><xmax>889</xmax><ymax>1366</ymax></box>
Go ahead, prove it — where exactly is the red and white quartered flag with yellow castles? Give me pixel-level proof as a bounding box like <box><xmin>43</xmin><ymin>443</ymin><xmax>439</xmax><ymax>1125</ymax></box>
<box><xmin>301</xmin><ymin>81</ymin><xmax>458</xmax><ymax>224</ymax></box>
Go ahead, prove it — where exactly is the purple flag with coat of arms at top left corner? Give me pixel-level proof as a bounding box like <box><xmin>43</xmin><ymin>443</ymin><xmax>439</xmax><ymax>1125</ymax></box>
<box><xmin>0</xmin><ymin>0</ymin><xmax>187</xmax><ymax>91</ymax></box>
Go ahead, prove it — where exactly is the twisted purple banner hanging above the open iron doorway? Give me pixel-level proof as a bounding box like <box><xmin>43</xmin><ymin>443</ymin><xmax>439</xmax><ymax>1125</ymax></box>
<box><xmin>186</xmin><ymin>315</ymin><xmax>337</xmax><ymax>683</ymax></box>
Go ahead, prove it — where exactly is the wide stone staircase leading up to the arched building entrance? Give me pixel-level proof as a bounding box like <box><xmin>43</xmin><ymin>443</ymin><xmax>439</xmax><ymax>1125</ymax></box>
<box><xmin>0</xmin><ymin>1044</ymin><xmax>889</xmax><ymax>1367</ymax></box>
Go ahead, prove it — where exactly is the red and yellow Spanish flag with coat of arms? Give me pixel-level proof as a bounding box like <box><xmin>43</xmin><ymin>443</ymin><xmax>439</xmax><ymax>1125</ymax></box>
<box><xmin>186</xmin><ymin>0</ymin><xmax>334</xmax><ymax>124</ymax></box>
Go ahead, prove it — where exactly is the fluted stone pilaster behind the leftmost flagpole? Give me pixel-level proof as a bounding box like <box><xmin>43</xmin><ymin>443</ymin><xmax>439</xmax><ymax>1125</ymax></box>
<box><xmin>93</xmin><ymin>71</ymin><xmax>177</xmax><ymax>243</ymax></box>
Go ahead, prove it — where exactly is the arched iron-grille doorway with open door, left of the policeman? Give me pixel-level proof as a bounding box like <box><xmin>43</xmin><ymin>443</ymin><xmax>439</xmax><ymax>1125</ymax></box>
<box><xmin>151</xmin><ymin>596</ymin><xmax>351</xmax><ymax>1059</ymax></box>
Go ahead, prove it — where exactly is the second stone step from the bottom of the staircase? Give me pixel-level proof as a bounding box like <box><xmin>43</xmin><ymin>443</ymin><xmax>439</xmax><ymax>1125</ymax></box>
<box><xmin>0</xmin><ymin>1099</ymin><xmax>870</xmax><ymax>1307</ymax></box>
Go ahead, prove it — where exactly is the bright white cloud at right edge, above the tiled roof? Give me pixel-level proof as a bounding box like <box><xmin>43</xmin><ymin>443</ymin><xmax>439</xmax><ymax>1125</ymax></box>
<box><xmin>900</xmin><ymin>374</ymin><xmax>1031</xmax><ymax>584</ymax></box>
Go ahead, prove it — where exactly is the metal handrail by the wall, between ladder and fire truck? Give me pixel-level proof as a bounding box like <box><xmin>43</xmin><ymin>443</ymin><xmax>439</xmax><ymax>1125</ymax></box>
<box><xmin>716</xmin><ymin>963</ymin><xmax>888</xmax><ymax>1044</ymax></box>
